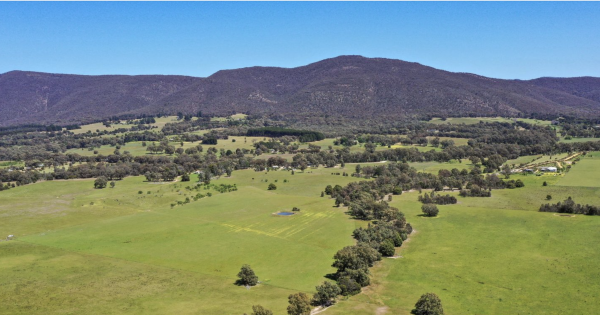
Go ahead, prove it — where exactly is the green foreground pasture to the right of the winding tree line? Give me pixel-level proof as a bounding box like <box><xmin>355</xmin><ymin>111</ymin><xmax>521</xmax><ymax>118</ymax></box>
<box><xmin>327</xmin><ymin>167</ymin><xmax>600</xmax><ymax>315</ymax></box>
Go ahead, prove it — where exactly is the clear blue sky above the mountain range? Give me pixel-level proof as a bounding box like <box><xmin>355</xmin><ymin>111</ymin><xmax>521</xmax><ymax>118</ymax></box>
<box><xmin>0</xmin><ymin>2</ymin><xmax>600</xmax><ymax>79</ymax></box>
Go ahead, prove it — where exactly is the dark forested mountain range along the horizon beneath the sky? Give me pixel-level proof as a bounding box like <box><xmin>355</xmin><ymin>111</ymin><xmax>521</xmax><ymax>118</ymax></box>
<box><xmin>0</xmin><ymin>56</ymin><xmax>600</xmax><ymax>125</ymax></box>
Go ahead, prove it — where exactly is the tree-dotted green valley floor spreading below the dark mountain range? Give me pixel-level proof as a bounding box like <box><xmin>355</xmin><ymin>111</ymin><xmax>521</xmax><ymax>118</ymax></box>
<box><xmin>0</xmin><ymin>113</ymin><xmax>600</xmax><ymax>315</ymax></box>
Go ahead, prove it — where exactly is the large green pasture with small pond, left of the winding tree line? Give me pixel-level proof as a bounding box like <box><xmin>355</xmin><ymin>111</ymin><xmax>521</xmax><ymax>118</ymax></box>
<box><xmin>0</xmin><ymin>168</ymin><xmax>364</xmax><ymax>314</ymax></box>
